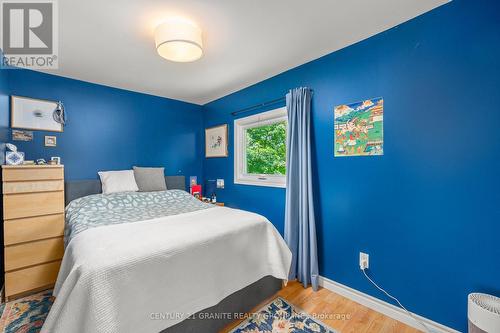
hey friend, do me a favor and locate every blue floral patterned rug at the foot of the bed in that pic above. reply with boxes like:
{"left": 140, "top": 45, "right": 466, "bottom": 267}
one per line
{"left": 230, "top": 297, "right": 338, "bottom": 333}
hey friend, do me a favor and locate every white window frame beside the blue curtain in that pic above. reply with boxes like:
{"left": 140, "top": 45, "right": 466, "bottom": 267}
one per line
{"left": 234, "top": 107, "right": 288, "bottom": 188}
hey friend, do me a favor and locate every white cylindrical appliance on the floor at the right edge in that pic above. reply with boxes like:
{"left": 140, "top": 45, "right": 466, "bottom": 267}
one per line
{"left": 468, "top": 293, "right": 500, "bottom": 333}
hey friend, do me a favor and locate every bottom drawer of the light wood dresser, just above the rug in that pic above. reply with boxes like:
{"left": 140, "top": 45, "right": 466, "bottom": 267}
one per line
{"left": 5, "top": 261, "right": 61, "bottom": 297}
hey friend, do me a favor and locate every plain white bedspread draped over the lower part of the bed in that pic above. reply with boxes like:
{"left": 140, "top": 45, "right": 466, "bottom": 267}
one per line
{"left": 42, "top": 207, "right": 291, "bottom": 333}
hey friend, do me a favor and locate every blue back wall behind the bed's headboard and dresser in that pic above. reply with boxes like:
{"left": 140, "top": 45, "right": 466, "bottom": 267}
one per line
{"left": 2, "top": 70, "right": 203, "bottom": 179}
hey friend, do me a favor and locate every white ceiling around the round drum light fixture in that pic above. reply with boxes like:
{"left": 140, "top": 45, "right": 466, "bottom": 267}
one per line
{"left": 43, "top": 0, "right": 448, "bottom": 104}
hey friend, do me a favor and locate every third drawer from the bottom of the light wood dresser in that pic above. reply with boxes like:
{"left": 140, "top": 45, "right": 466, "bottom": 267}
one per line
{"left": 3, "top": 214, "right": 64, "bottom": 245}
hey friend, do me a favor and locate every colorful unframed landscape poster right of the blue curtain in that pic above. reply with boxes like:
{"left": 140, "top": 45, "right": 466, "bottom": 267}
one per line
{"left": 334, "top": 97, "right": 384, "bottom": 157}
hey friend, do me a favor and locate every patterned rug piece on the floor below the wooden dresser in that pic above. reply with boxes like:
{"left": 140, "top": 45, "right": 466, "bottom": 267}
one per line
{"left": 0, "top": 290, "right": 54, "bottom": 333}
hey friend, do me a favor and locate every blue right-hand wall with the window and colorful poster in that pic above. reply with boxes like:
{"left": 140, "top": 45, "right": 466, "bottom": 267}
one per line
{"left": 204, "top": 0, "right": 500, "bottom": 331}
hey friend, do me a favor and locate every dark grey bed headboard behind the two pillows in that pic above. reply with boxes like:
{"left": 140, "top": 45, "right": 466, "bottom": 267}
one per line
{"left": 64, "top": 176, "right": 186, "bottom": 205}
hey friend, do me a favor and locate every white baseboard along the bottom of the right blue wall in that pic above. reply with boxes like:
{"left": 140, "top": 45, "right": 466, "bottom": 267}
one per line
{"left": 319, "top": 276, "right": 460, "bottom": 333}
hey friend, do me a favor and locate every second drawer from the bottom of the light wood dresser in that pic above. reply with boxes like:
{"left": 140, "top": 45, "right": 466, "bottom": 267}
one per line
{"left": 5, "top": 237, "right": 64, "bottom": 271}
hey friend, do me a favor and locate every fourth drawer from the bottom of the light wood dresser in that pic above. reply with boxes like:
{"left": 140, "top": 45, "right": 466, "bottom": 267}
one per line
{"left": 3, "top": 191, "right": 64, "bottom": 220}
